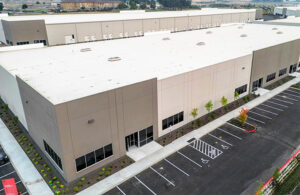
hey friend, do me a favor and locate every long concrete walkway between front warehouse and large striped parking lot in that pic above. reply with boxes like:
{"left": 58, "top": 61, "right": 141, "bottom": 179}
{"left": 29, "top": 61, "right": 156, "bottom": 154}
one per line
{"left": 78, "top": 74, "right": 300, "bottom": 195}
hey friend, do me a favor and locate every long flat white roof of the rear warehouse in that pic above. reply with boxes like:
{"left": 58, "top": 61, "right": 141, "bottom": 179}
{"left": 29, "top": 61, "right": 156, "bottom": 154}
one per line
{"left": 4, "top": 8, "right": 255, "bottom": 24}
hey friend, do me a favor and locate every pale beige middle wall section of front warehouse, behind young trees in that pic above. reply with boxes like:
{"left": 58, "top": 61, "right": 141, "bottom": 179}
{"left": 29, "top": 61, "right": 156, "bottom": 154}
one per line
{"left": 157, "top": 54, "right": 252, "bottom": 136}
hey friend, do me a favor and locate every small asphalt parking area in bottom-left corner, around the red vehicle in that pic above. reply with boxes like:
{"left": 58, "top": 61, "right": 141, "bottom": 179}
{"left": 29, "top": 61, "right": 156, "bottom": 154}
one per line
{"left": 0, "top": 146, "right": 28, "bottom": 195}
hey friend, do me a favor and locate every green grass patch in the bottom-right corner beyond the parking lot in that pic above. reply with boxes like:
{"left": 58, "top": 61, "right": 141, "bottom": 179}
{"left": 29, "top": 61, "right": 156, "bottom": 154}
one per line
{"left": 274, "top": 165, "right": 300, "bottom": 195}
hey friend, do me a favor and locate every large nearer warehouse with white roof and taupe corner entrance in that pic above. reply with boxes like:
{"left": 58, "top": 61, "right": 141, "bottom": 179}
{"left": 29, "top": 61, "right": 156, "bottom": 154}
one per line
{"left": 0, "top": 24, "right": 300, "bottom": 182}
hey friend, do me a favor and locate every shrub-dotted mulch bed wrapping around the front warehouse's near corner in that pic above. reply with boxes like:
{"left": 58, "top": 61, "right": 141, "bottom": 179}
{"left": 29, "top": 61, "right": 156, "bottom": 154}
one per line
{"left": 0, "top": 99, "right": 134, "bottom": 194}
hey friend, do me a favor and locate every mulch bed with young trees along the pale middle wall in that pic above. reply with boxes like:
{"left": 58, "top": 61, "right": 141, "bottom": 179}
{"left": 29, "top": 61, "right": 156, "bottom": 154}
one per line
{"left": 156, "top": 94, "right": 258, "bottom": 146}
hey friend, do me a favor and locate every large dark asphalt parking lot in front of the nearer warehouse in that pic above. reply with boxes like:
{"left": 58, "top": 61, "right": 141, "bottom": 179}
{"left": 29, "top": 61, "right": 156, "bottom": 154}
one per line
{"left": 106, "top": 88, "right": 300, "bottom": 195}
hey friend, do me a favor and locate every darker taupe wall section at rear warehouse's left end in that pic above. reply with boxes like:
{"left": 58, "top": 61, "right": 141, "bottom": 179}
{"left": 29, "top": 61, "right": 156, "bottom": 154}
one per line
{"left": 2, "top": 20, "right": 48, "bottom": 45}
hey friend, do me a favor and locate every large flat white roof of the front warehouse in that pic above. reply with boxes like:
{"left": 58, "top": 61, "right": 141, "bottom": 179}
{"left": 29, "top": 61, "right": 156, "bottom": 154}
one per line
{"left": 0, "top": 24, "right": 300, "bottom": 104}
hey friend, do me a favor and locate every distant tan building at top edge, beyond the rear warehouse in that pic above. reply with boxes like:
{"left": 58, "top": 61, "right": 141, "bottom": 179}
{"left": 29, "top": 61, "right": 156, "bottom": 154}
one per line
{"left": 61, "top": 0, "right": 121, "bottom": 10}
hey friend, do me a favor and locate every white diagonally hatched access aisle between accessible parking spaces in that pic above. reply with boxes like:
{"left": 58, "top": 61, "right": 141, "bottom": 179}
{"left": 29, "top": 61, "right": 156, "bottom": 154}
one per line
{"left": 189, "top": 139, "right": 223, "bottom": 159}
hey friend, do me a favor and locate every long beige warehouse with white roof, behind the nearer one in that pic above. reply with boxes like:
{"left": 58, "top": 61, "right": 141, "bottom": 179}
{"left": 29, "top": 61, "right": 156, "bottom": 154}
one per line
{"left": 0, "top": 9, "right": 256, "bottom": 46}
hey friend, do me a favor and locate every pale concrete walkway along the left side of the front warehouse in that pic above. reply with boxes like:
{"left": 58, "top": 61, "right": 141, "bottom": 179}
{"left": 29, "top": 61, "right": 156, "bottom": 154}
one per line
{"left": 0, "top": 120, "right": 53, "bottom": 195}
